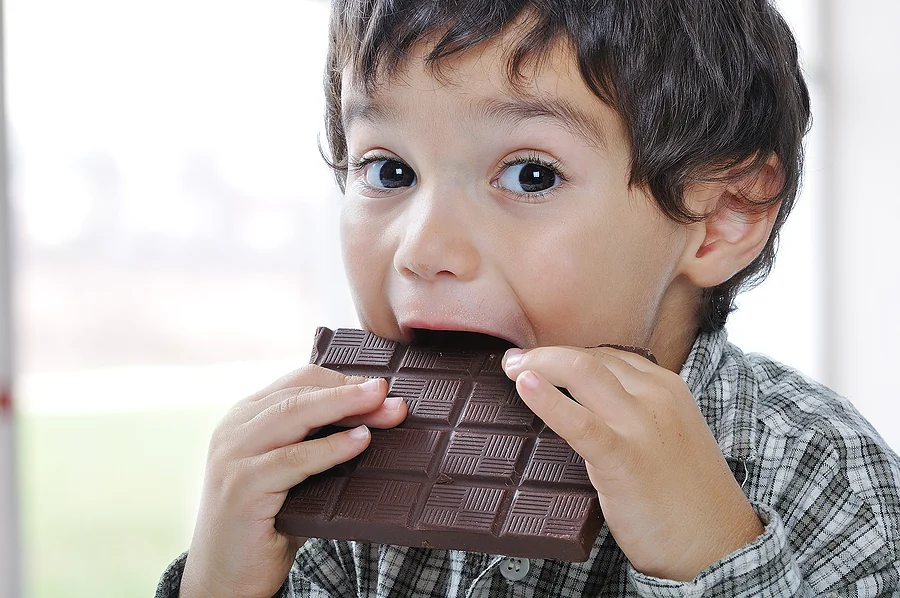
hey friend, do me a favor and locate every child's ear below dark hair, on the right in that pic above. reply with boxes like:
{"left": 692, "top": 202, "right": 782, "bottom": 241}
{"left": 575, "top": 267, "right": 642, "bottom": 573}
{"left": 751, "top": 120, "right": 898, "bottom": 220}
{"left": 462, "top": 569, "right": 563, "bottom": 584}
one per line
{"left": 680, "top": 155, "right": 782, "bottom": 288}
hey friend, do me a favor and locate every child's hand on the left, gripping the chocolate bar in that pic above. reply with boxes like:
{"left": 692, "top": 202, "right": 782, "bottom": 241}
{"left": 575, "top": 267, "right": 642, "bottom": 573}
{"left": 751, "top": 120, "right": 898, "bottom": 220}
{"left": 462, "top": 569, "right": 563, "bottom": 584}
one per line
{"left": 180, "top": 365, "right": 406, "bottom": 598}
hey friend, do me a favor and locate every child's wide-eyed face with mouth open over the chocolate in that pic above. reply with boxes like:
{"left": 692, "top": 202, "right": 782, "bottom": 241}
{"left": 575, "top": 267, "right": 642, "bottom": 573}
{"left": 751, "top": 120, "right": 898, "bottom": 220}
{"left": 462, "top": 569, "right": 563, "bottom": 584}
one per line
{"left": 341, "top": 39, "right": 696, "bottom": 348}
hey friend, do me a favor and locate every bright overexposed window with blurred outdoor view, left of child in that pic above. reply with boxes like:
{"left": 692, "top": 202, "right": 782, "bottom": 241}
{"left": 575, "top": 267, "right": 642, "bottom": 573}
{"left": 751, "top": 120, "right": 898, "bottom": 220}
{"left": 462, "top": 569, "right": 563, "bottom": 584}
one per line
{"left": 3, "top": 0, "right": 355, "bottom": 597}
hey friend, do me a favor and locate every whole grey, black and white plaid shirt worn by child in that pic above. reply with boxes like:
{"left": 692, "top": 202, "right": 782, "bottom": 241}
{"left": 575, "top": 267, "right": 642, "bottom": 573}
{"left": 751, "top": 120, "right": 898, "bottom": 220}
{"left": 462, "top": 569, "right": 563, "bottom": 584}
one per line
{"left": 156, "top": 331, "right": 900, "bottom": 598}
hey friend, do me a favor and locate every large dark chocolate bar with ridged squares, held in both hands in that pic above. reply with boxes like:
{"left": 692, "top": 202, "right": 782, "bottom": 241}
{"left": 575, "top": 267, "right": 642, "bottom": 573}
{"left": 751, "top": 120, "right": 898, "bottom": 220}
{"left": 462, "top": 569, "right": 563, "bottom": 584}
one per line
{"left": 275, "top": 328, "right": 603, "bottom": 561}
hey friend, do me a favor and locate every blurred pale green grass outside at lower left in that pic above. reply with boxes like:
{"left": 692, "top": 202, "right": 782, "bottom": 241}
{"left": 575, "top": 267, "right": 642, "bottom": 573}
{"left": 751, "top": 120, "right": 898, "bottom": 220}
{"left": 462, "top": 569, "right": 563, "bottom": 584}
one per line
{"left": 17, "top": 408, "right": 224, "bottom": 598}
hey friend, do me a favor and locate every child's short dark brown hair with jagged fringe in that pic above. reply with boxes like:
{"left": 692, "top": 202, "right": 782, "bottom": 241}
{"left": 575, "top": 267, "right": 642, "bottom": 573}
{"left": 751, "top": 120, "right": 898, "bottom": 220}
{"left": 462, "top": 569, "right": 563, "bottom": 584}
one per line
{"left": 325, "top": 0, "right": 810, "bottom": 331}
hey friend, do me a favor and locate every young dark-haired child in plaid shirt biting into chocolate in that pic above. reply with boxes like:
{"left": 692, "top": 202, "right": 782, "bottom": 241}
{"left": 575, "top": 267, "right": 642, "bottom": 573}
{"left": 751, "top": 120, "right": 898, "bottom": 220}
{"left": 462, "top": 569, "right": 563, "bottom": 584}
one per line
{"left": 157, "top": 0, "right": 900, "bottom": 598}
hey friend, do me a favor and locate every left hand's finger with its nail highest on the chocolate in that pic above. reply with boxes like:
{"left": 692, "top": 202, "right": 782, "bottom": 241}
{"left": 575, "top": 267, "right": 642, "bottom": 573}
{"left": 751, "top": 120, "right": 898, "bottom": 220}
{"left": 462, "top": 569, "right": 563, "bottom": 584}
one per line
{"left": 241, "top": 378, "right": 387, "bottom": 455}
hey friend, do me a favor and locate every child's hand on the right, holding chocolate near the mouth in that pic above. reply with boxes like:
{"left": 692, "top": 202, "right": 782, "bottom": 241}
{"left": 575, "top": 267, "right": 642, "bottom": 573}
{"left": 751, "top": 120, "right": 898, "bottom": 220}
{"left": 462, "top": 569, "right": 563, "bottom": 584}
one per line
{"left": 504, "top": 347, "right": 763, "bottom": 581}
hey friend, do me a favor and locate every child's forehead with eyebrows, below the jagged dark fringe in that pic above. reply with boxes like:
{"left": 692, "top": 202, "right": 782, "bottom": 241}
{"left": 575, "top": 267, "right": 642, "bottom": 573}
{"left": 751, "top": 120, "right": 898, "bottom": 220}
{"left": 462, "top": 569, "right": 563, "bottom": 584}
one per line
{"left": 341, "top": 37, "right": 622, "bottom": 151}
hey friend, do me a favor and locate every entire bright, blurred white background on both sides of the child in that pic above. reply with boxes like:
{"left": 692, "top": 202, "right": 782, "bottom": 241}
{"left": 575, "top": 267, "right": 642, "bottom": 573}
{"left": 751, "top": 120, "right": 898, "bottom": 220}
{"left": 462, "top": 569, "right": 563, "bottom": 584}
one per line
{"left": 0, "top": 0, "right": 900, "bottom": 598}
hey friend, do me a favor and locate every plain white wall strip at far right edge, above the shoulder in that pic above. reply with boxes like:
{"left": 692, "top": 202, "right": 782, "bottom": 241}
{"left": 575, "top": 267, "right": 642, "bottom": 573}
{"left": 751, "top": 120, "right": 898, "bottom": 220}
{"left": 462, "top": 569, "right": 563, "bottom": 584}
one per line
{"left": 823, "top": 0, "right": 900, "bottom": 449}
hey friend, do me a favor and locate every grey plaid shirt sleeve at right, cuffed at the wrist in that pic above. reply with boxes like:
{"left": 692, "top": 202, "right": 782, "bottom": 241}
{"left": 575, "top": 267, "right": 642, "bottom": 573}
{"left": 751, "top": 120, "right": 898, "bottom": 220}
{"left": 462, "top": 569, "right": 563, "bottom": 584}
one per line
{"left": 628, "top": 424, "right": 900, "bottom": 598}
